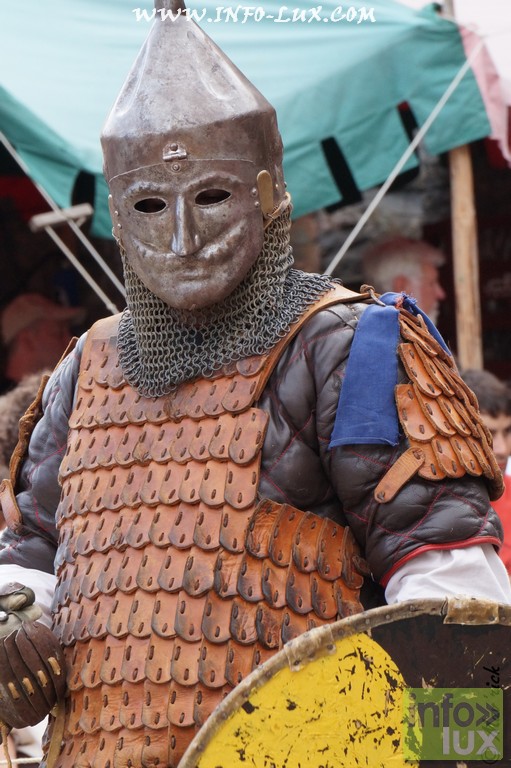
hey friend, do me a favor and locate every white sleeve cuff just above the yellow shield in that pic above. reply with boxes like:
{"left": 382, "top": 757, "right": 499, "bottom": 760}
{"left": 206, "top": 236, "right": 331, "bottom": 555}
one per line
{"left": 385, "top": 544, "right": 511, "bottom": 604}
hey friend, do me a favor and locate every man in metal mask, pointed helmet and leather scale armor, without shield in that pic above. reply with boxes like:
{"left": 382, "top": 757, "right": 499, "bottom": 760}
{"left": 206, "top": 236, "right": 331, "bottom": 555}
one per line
{"left": 0, "top": 2, "right": 511, "bottom": 768}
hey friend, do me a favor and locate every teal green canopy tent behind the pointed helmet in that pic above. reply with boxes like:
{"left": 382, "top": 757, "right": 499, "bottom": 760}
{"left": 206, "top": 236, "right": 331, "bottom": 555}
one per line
{"left": 0, "top": 0, "right": 490, "bottom": 237}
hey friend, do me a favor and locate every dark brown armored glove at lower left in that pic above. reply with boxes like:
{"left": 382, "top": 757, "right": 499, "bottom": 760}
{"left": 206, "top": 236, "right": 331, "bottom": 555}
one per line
{"left": 0, "top": 583, "right": 66, "bottom": 728}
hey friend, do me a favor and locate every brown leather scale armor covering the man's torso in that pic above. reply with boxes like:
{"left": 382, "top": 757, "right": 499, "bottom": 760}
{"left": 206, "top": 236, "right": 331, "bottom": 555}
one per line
{"left": 46, "top": 287, "right": 363, "bottom": 768}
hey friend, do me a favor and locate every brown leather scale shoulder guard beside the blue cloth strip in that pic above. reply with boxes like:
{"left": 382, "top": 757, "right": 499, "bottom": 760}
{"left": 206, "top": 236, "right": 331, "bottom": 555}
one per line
{"left": 374, "top": 309, "right": 504, "bottom": 503}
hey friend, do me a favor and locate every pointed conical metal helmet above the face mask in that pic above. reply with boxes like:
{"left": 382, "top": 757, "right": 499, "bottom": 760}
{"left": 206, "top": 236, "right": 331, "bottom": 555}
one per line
{"left": 101, "top": 0, "right": 286, "bottom": 215}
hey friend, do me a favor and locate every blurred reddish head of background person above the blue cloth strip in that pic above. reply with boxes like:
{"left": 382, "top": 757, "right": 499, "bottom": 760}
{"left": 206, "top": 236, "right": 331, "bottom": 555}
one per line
{"left": 362, "top": 237, "right": 446, "bottom": 324}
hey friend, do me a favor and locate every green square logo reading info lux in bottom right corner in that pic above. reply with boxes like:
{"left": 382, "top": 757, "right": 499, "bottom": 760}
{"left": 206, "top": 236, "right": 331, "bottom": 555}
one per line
{"left": 403, "top": 688, "right": 503, "bottom": 761}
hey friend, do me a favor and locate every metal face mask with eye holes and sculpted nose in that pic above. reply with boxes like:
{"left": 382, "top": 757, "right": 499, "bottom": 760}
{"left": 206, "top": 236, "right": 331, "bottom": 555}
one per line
{"left": 110, "top": 159, "right": 264, "bottom": 309}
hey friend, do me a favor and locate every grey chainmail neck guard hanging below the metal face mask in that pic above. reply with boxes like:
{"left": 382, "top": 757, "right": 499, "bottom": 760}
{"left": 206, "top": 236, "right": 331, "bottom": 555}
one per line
{"left": 117, "top": 211, "right": 339, "bottom": 397}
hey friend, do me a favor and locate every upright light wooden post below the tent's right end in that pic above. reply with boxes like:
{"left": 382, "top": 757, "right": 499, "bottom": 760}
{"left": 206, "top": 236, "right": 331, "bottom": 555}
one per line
{"left": 449, "top": 145, "right": 484, "bottom": 369}
